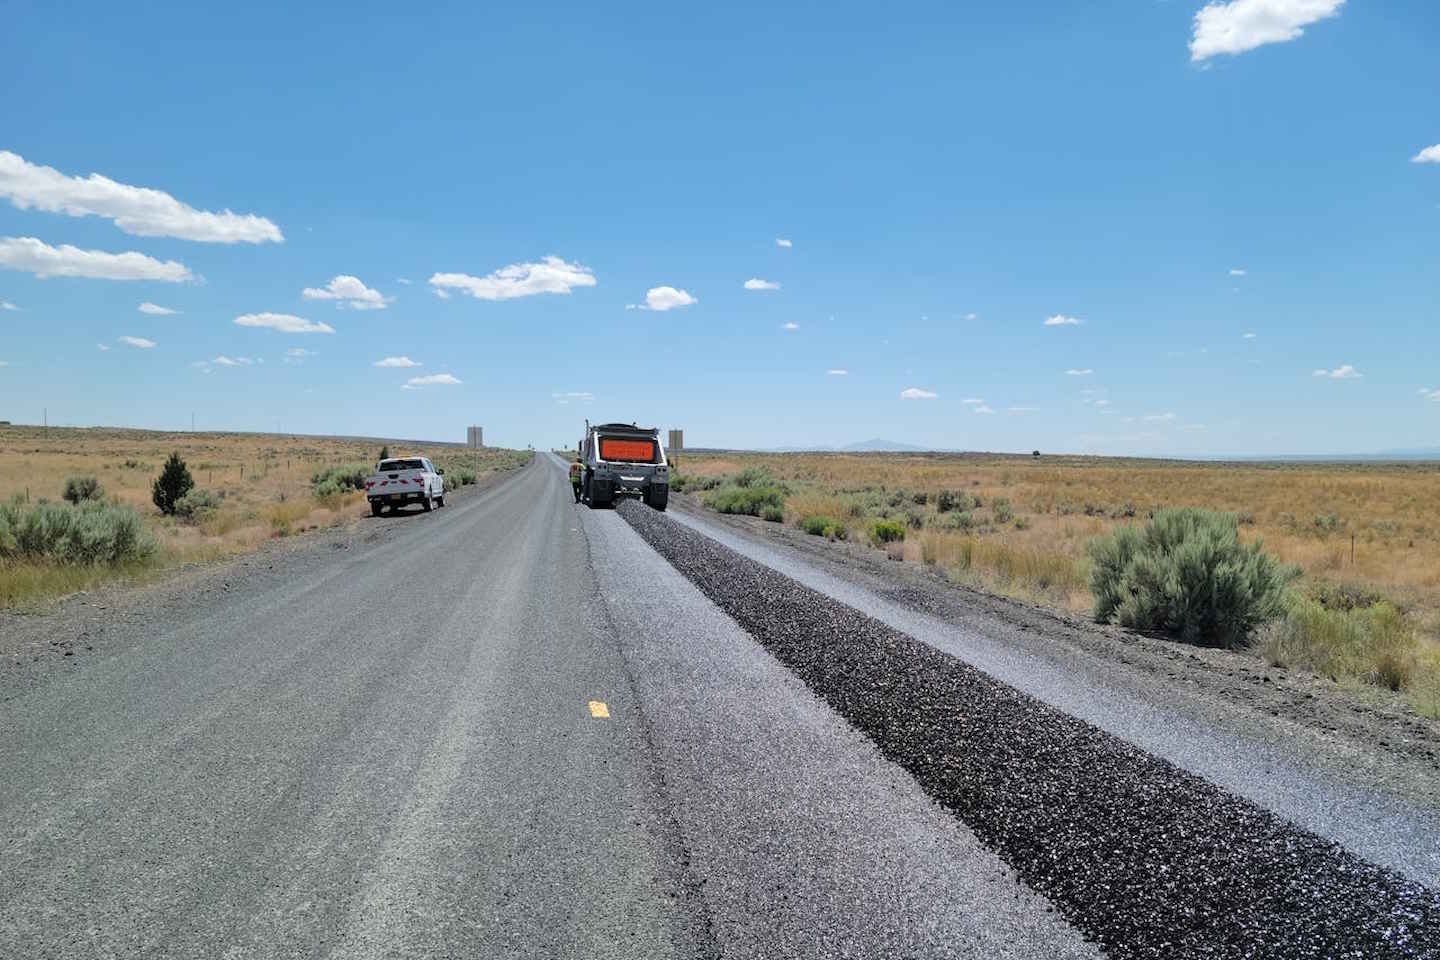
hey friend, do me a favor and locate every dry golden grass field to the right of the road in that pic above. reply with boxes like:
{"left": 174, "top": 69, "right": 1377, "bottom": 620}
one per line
{"left": 680, "top": 453, "right": 1440, "bottom": 712}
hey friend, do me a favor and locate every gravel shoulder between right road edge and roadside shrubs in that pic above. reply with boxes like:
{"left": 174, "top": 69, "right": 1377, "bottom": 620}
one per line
{"left": 671, "top": 495, "right": 1440, "bottom": 788}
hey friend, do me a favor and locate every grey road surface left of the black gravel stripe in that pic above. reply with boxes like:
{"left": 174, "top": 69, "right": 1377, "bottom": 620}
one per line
{"left": 0, "top": 458, "right": 1096, "bottom": 960}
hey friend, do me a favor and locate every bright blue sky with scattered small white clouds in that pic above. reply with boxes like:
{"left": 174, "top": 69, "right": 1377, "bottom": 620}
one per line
{"left": 0, "top": 0, "right": 1440, "bottom": 455}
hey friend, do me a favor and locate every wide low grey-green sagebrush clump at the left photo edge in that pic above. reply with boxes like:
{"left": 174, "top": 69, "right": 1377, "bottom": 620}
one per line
{"left": 0, "top": 499, "right": 156, "bottom": 564}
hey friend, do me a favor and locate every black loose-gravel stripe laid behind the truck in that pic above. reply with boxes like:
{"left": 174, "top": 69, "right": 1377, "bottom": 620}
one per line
{"left": 619, "top": 502, "right": 1440, "bottom": 960}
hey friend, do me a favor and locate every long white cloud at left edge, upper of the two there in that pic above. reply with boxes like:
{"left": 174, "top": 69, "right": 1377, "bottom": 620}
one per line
{"left": 0, "top": 150, "right": 285, "bottom": 243}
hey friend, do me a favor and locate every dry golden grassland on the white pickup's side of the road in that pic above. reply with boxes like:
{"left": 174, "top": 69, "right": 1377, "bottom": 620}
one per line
{"left": 0, "top": 426, "right": 528, "bottom": 607}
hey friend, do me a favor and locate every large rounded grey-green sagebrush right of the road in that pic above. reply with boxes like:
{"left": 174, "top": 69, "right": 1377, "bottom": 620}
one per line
{"left": 1089, "top": 507, "right": 1299, "bottom": 648}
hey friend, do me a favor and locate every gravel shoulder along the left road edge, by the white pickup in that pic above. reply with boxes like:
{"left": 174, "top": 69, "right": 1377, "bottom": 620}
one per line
{"left": 0, "top": 468, "right": 526, "bottom": 704}
